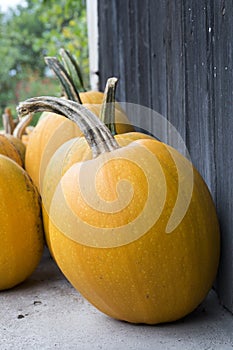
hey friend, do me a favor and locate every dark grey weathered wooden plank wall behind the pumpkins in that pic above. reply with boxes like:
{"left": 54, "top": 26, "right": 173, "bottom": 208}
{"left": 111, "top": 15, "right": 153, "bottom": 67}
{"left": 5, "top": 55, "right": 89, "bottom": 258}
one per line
{"left": 98, "top": 0, "right": 233, "bottom": 311}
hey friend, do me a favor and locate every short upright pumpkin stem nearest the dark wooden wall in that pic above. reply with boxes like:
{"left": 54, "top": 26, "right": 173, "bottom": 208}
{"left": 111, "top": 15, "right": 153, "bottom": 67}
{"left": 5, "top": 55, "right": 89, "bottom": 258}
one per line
{"left": 100, "top": 77, "right": 118, "bottom": 135}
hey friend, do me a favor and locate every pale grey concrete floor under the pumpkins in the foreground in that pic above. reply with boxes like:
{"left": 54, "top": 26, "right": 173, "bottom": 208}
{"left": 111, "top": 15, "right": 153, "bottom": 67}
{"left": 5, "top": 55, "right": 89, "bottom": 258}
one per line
{"left": 0, "top": 252, "right": 233, "bottom": 350}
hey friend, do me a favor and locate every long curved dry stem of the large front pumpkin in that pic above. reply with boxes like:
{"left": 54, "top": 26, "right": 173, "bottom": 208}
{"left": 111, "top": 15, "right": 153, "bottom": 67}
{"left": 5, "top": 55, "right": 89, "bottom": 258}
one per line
{"left": 17, "top": 96, "right": 120, "bottom": 157}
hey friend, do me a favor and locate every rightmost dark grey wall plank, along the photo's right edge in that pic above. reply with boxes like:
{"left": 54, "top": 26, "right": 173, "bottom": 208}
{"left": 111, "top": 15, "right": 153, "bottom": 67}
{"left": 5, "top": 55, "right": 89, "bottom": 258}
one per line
{"left": 212, "top": 0, "right": 233, "bottom": 311}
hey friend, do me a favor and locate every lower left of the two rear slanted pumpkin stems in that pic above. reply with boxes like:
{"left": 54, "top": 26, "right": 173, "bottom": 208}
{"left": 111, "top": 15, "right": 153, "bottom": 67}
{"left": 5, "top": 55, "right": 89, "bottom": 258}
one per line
{"left": 44, "top": 57, "right": 82, "bottom": 104}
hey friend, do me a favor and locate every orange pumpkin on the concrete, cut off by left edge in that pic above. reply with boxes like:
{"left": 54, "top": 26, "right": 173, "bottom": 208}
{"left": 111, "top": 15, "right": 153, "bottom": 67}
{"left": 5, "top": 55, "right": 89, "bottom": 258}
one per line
{"left": 0, "top": 156, "right": 44, "bottom": 290}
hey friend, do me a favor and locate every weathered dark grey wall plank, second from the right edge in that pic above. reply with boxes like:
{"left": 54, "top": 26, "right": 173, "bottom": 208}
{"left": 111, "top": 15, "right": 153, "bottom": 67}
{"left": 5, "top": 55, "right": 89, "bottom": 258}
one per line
{"left": 184, "top": 0, "right": 215, "bottom": 193}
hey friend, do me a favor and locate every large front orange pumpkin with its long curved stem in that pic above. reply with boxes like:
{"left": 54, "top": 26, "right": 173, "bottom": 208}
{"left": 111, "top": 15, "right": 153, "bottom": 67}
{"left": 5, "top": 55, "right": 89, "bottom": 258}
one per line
{"left": 18, "top": 97, "right": 220, "bottom": 324}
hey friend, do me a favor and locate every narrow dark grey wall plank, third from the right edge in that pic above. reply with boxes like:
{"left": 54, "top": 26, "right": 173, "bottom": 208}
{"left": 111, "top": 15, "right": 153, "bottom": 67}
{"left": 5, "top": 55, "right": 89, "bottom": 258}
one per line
{"left": 166, "top": 1, "right": 188, "bottom": 151}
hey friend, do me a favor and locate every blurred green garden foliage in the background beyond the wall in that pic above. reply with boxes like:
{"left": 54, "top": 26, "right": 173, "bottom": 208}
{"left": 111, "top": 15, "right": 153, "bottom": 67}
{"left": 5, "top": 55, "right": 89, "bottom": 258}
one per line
{"left": 0, "top": 0, "right": 89, "bottom": 126}
